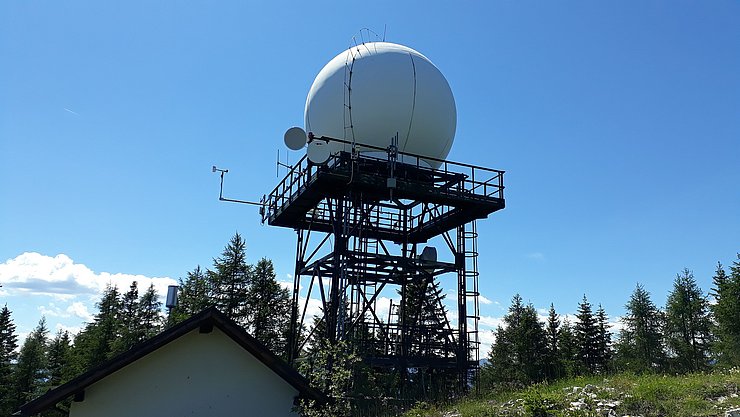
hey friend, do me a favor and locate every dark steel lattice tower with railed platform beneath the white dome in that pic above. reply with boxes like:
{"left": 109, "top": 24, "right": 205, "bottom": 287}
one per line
{"left": 262, "top": 138, "right": 505, "bottom": 398}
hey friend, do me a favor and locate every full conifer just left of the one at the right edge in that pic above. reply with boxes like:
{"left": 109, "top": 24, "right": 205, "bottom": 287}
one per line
{"left": 665, "top": 269, "right": 711, "bottom": 372}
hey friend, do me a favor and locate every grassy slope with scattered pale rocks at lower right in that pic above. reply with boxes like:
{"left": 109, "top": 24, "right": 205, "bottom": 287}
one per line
{"left": 405, "top": 369, "right": 740, "bottom": 417}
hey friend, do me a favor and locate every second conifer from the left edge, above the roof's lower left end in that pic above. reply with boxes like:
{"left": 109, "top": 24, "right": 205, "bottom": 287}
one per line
{"left": 11, "top": 317, "right": 49, "bottom": 408}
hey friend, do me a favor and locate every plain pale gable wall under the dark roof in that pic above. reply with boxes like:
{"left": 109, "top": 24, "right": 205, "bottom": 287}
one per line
{"left": 70, "top": 327, "right": 298, "bottom": 417}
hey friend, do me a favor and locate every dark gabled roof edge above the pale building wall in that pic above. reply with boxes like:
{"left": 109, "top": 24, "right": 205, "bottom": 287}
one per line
{"left": 15, "top": 307, "right": 328, "bottom": 416}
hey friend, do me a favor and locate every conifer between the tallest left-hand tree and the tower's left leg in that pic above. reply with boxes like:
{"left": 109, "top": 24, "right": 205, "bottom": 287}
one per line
{"left": 246, "top": 258, "right": 291, "bottom": 357}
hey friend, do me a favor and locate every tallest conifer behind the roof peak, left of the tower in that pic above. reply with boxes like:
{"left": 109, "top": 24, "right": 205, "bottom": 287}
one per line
{"left": 208, "top": 233, "right": 251, "bottom": 326}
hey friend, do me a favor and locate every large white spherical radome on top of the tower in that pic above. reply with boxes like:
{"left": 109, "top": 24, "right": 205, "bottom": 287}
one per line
{"left": 305, "top": 42, "right": 457, "bottom": 168}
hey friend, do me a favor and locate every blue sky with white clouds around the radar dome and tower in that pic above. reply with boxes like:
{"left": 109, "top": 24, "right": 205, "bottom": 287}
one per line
{"left": 0, "top": 1, "right": 740, "bottom": 353}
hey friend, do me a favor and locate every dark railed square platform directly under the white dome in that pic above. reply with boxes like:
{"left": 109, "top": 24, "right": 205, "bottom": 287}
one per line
{"left": 262, "top": 141, "right": 505, "bottom": 243}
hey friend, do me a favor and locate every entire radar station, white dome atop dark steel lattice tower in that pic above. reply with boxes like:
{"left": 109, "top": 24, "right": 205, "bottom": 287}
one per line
{"left": 214, "top": 42, "right": 505, "bottom": 397}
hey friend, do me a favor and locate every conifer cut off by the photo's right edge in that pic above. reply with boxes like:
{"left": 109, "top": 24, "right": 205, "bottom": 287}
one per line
{"left": 712, "top": 254, "right": 740, "bottom": 366}
